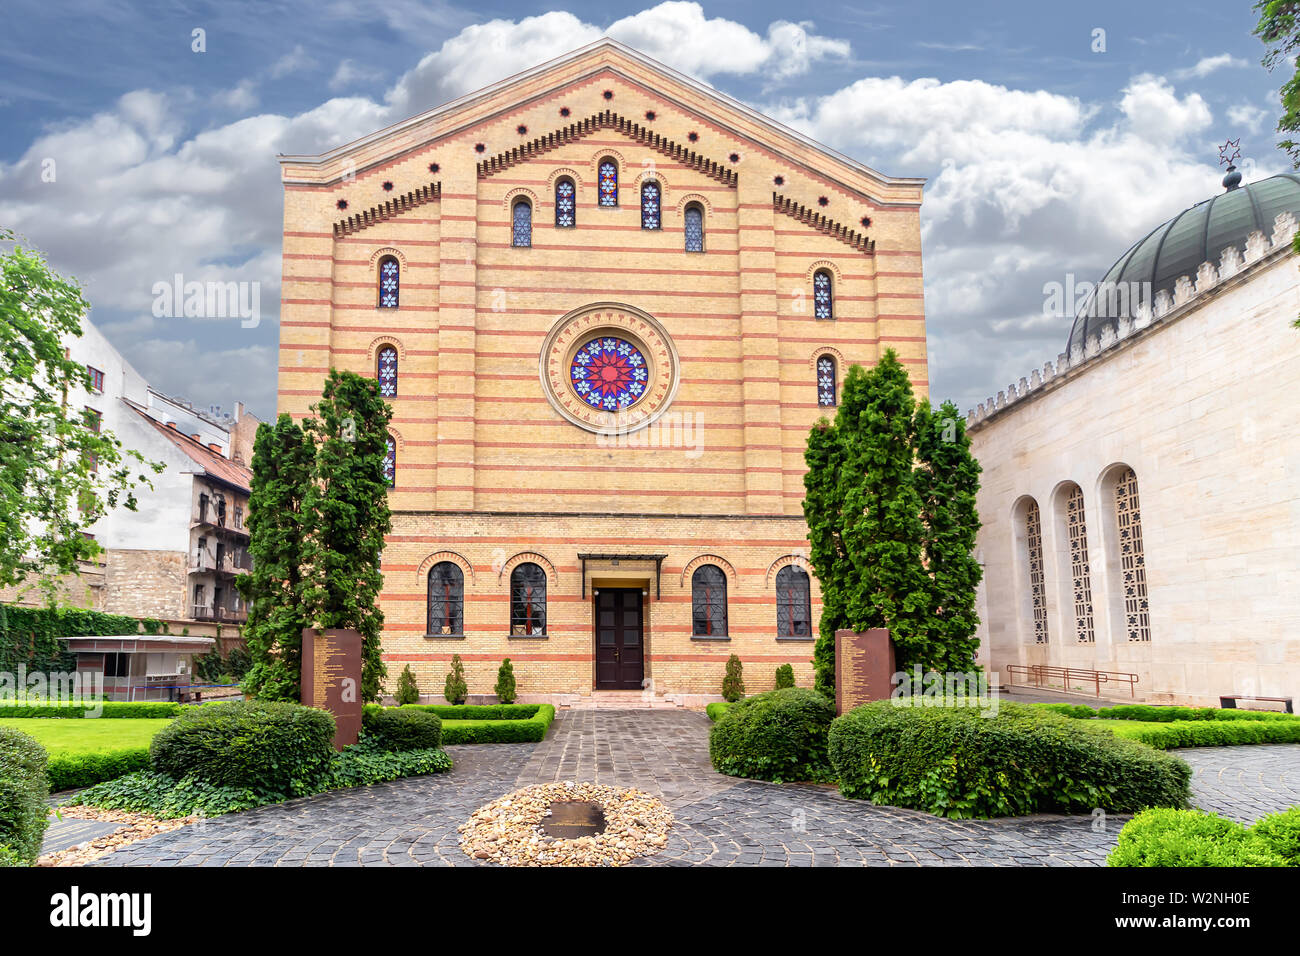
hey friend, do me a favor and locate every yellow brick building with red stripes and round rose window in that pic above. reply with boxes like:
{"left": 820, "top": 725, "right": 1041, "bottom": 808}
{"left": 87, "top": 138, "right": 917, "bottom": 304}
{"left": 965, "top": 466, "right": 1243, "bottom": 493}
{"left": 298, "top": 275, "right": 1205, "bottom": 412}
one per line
{"left": 280, "top": 40, "right": 927, "bottom": 700}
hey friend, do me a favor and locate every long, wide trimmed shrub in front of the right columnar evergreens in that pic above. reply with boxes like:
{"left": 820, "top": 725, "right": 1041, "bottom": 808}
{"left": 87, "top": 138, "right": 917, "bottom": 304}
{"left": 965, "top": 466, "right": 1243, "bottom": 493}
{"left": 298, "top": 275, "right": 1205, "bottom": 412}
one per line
{"left": 829, "top": 701, "right": 1191, "bottom": 818}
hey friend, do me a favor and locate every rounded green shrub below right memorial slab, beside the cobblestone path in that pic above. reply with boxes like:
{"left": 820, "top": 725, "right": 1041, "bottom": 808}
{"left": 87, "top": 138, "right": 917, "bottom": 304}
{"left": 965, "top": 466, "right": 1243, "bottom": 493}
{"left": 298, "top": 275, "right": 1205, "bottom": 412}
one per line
{"left": 709, "top": 687, "right": 835, "bottom": 783}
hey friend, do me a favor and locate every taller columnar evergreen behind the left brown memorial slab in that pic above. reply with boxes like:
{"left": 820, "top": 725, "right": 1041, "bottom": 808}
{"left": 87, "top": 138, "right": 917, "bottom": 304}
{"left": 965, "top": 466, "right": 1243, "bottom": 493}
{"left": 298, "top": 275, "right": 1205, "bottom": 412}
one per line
{"left": 302, "top": 368, "right": 393, "bottom": 701}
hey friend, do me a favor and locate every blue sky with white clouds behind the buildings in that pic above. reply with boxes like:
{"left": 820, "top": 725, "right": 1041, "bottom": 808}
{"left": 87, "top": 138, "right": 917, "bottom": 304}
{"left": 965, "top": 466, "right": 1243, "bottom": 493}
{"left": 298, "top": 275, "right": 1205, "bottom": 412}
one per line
{"left": 0, "top": 0, "right": 1287, "bottom": 416}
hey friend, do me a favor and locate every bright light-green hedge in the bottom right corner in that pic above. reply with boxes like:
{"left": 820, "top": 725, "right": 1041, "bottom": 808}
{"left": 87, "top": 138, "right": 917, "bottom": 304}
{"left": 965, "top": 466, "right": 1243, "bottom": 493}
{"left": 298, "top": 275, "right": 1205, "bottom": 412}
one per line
{"left": 1106, "top": 806, "right": 1300, "bottom": 866}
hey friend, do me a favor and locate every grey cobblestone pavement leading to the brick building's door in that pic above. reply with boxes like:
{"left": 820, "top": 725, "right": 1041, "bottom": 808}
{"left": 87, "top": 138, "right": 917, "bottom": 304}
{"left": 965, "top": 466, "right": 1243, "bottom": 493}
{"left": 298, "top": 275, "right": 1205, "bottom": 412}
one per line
{"left": 86, "top": 710, "right": 1300, "bottom": 866}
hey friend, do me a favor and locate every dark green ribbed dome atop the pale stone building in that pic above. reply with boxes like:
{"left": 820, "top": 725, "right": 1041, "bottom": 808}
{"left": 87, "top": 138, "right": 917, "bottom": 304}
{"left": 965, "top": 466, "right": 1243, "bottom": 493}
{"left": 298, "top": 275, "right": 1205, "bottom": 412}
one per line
{"left": 1066, "top": 173, "right": 1300, "bottom": 350}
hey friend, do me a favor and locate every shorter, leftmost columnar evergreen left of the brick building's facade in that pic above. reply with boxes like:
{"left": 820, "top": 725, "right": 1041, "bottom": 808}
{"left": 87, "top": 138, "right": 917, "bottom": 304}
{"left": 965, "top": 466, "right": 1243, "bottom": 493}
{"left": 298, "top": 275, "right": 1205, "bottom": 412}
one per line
{"left": 235, "top": 414, "right": 315, "bottom": 701}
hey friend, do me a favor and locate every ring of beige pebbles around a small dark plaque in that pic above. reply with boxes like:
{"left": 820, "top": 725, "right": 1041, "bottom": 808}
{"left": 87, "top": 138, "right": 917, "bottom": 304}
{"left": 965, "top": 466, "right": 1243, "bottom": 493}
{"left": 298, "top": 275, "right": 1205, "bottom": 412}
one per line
{"left": 459, "top": 782, "right": 672, "bottom": 866}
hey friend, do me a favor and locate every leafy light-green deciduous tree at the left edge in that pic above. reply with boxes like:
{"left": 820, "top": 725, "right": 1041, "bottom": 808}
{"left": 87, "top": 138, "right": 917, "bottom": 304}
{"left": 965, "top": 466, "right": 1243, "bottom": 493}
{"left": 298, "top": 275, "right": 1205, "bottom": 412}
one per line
{"left": 0, "top": 230, "right": 164, "bottom": 605}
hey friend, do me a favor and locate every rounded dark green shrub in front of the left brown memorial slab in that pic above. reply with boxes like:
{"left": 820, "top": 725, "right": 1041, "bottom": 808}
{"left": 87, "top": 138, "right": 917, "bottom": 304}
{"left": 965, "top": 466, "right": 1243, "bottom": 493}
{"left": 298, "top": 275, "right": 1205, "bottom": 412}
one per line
{"left": 150, "top": 701, "right": 334, "bottom": 796}
